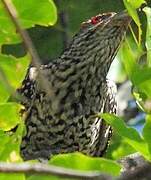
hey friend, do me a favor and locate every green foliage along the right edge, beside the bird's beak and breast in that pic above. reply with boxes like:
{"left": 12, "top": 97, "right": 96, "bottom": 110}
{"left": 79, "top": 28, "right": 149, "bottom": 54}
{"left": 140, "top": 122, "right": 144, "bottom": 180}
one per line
{"left": 104, "top": 1, "right": 151, "bottom": 160}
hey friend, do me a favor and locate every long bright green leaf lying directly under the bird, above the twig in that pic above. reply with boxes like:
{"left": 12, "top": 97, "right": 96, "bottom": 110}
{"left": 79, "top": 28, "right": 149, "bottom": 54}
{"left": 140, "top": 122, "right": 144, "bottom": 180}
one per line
{"left": 50, "top": 153, "right": 121, "bottom": 176}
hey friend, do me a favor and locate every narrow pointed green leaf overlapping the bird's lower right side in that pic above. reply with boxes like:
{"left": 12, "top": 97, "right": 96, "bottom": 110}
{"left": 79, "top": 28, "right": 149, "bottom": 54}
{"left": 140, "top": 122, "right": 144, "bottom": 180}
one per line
{"left": 99, "top": 113, "right": 151, "bottom": 159}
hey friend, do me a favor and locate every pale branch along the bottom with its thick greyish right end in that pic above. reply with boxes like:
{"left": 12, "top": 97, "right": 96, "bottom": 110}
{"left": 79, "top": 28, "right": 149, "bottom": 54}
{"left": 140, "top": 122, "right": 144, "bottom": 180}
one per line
{"left": 0, "top": 153, "right": 151, "bottom": 180}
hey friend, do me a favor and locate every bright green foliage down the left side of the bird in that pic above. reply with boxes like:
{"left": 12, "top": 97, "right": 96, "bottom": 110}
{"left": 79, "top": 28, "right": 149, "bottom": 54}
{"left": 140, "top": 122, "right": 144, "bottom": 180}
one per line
{"left": 0, "top": 0, "right": 57, "bottom": 180}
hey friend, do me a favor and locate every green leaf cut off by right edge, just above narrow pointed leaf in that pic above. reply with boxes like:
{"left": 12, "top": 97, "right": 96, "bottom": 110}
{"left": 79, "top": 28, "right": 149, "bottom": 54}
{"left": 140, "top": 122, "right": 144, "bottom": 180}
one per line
{"left": 143, "top": 115, "right": 151, "bottom": 154}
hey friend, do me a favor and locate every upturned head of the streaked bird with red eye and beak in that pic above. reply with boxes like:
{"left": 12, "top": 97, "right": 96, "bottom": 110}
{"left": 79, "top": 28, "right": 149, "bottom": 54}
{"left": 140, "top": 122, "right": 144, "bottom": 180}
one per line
{"left": 80, "top": 12, "right": 131, "bottom": 43}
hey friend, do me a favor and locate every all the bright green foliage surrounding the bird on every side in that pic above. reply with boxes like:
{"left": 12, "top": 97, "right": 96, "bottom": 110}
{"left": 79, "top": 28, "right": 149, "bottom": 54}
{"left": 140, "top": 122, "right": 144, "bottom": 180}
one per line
{"left": 0, "top": 0, "right": 151, "bottom": 180}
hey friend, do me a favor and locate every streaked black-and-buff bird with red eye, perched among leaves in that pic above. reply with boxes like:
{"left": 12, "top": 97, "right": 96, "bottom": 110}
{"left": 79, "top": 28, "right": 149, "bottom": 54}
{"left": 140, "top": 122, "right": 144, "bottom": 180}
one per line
{"left": 18, "top": 11, "right": 131, "bottom": 160}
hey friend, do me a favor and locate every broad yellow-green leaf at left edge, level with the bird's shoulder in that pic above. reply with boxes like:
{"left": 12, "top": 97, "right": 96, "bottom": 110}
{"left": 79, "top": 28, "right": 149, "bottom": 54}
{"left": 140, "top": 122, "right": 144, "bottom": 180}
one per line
{"left": 0, "top": 54, "right": 30, "bottom": 103}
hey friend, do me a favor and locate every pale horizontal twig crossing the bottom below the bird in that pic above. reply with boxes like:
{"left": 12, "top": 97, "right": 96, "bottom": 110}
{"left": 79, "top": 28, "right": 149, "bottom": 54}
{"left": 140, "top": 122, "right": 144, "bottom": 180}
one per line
{"left": 0, "top": 163, "right": 111, "bottom": 180}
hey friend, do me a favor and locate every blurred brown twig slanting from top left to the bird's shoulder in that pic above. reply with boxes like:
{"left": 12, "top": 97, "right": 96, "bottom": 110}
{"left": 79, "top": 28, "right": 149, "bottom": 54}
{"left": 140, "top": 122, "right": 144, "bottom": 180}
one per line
{"left": 2, "top": 0, "right": 51, "bottom": 96}
